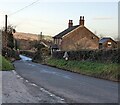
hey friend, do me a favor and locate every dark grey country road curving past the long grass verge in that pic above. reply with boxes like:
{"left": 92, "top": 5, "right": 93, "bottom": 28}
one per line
{"left": 14, "top": 56, "right": 118, "bottom": 103}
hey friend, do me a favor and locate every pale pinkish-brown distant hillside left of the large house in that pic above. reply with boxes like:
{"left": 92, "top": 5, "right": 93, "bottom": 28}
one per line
{"left": 14, "top": 32, "right": 52, "bottom": 41}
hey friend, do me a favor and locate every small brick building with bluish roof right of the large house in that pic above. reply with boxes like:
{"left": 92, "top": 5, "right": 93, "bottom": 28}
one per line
{"left": 99, "top": 37, "right": 117, "bottom": 49}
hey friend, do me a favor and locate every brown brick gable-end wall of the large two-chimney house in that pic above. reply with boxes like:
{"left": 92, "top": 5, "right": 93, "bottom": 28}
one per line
{"left": 61, "top": 26, "right": 99, "bottom": 51}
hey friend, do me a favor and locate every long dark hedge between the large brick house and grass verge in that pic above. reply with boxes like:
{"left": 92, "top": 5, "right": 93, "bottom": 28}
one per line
{"left": 52, "top": 49, "right": 120, "bottom": 63}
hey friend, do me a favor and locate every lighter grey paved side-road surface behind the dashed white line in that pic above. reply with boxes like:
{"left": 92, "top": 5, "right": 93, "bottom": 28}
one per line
{"left": 0, "top": 71, "right": 64, "bottom": 105}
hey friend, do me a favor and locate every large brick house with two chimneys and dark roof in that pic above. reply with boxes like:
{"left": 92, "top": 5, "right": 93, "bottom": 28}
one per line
{"left": 53, "top": 16, "right": 99, "bottom": 51}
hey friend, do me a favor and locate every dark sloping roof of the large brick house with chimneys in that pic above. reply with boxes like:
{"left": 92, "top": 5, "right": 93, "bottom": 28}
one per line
{"left": 53, "top": 25, "right": 80, "bottom": 38}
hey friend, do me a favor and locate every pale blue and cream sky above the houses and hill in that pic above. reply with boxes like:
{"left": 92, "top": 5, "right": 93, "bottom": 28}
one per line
{"left": 0, "top": 0, "right": 118, "bottom": 39}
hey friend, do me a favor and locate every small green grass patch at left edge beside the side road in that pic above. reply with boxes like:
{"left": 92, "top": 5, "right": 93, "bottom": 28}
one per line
{"left": 0, "top": 55, "right": 14, "bottom": 71}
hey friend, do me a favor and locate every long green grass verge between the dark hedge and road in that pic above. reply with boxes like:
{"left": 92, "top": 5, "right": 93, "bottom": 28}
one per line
{"left": 46, "top": 58, "right": 120, "bottom": 81}
